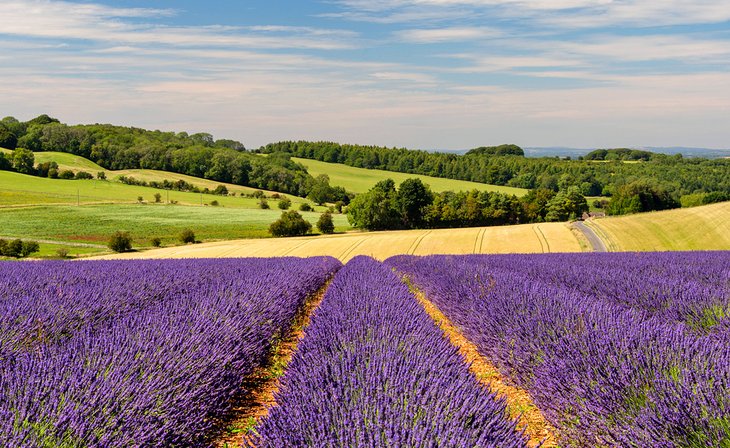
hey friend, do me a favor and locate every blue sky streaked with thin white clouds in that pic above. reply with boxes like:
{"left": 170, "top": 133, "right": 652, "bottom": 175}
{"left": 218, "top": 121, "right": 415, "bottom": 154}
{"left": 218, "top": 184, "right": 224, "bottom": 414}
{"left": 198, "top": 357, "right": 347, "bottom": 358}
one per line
{"left": 0, "top": 0, "right": 730, "bottom": 150}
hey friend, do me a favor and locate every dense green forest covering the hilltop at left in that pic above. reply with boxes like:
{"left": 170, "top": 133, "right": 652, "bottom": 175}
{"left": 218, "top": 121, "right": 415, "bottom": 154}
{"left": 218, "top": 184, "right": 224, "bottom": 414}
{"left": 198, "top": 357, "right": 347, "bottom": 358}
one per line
{"left": 0, "top": 115, "right": 315, "bottom": 196}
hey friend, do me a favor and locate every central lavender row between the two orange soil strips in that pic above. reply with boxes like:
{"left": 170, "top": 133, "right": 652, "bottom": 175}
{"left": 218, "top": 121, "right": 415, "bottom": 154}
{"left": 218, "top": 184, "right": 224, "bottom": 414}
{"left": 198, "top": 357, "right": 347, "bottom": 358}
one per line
{"left": 245, "top": 257, "right": 526, "bottom": 448}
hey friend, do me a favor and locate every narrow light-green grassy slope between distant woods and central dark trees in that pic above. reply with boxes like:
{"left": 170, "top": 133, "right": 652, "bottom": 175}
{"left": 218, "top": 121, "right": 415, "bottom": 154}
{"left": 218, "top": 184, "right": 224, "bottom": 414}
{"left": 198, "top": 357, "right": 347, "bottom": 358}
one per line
{"left": 292, "top": 157, "right": 527, "bottom": 196}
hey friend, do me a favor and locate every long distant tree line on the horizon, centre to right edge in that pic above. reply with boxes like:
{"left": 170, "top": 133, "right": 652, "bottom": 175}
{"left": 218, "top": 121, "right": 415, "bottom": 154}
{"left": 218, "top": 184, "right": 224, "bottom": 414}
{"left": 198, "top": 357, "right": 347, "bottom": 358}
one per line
{"left": 259, "top": 141, "right": 730, "bottom": 202}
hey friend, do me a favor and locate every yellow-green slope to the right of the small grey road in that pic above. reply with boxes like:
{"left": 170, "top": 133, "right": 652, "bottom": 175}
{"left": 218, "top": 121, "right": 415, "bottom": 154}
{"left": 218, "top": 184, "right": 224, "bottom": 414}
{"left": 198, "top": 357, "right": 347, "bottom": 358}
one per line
{"left": 591, "top": 202, "right": 730, "bottom": 251}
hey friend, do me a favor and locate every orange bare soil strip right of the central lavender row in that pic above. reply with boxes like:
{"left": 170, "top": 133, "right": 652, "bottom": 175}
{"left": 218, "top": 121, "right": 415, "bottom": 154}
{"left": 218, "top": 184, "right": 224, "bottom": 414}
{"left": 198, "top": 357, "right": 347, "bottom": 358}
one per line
{"left": 411, "top": 286, "right": 558, "bottom": 448}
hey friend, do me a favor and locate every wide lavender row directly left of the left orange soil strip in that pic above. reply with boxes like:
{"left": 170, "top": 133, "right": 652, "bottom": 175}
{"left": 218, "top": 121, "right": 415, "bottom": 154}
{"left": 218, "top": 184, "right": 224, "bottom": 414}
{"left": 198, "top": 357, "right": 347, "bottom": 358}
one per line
{"left": 0, "top": 258, "right": 341, "bottom": 447}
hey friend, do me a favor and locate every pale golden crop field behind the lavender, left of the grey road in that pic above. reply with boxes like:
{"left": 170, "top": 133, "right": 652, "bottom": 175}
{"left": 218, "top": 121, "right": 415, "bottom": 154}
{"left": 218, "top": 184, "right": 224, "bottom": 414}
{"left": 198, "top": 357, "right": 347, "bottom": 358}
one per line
{"left": 103, "top": 223, "right": 581, "bottom": 262}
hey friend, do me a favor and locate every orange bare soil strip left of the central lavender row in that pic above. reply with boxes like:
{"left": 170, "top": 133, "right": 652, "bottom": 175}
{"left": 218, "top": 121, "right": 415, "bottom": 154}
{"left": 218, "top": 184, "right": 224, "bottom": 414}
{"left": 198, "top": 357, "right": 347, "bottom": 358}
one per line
{"left": 210, "top": 279, "right": 332, "bottom": 448}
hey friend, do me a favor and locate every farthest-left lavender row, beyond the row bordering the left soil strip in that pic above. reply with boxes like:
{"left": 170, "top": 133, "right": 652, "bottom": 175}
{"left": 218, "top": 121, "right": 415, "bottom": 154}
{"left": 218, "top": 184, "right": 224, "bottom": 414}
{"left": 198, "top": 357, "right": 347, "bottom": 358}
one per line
{"left": 0, "top": 261, "right": 236, "bottom": 356}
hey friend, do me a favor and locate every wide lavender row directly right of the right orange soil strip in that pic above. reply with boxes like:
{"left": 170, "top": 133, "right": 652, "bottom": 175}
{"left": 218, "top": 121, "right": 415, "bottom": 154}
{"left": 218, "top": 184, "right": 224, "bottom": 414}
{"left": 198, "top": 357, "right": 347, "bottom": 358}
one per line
{"left": 386, "top": 254, "right": 730, "bottom": 447}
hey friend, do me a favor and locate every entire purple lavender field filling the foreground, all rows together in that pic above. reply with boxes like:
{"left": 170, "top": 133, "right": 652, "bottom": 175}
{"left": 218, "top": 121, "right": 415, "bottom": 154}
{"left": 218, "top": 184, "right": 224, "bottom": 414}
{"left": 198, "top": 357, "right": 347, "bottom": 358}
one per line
{"left": 0, "top": 252, "right": 730, "bottom": 448}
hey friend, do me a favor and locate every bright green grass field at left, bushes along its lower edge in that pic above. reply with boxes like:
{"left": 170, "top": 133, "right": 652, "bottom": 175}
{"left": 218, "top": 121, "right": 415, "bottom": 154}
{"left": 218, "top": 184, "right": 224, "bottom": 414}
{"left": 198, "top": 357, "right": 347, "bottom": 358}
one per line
{"left": 0, "top": 204, "right": 350, "bottom": 253}
